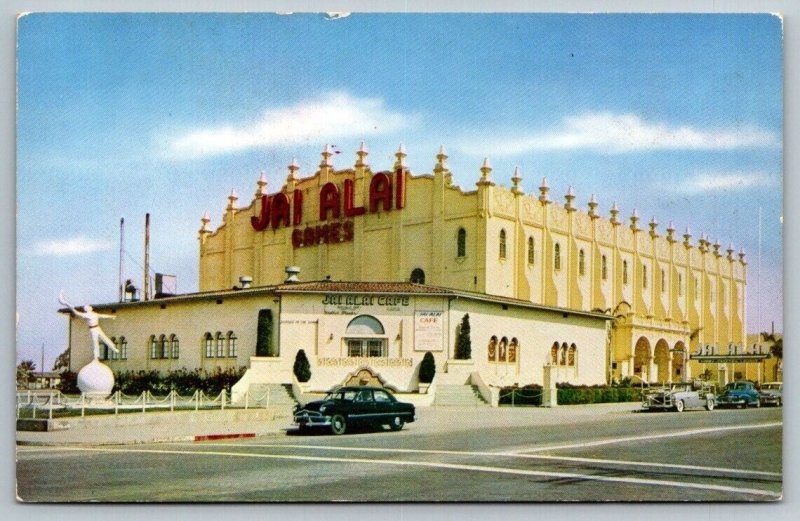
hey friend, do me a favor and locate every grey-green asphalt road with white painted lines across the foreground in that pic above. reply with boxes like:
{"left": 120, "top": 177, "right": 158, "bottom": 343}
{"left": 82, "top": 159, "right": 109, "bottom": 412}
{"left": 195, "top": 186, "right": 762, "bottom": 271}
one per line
{"left": 17, "top": 408, "right": 782, "bottom": 502}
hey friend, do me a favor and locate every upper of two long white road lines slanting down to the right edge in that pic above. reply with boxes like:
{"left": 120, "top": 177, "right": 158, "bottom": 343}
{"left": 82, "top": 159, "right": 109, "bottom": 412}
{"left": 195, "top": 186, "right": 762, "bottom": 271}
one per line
{"left": 200, "top": 443, "right": 783, "bottom": 477}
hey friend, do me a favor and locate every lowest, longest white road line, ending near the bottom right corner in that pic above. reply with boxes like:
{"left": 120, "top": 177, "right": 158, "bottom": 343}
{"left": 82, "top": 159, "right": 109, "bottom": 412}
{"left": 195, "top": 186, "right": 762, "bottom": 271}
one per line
{"left": 25, "top": 447, "right": 783, "bottom": 499}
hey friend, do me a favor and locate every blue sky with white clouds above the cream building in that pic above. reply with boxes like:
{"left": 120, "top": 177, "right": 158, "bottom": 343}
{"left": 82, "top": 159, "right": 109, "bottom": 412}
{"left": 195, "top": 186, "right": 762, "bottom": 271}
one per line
{"left": 17, "top": 13, "right": 783, "bottom": 370}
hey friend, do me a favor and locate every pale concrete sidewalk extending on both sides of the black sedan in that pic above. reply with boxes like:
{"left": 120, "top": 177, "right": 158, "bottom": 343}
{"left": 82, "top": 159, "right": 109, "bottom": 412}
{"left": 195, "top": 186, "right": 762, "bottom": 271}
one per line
{"left": 17, "top": 402, "right": 641, "bottom": 445}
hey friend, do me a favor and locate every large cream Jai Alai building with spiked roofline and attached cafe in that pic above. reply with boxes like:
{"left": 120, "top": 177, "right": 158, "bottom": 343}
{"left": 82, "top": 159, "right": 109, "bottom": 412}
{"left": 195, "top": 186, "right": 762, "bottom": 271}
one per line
{"left": 71, "top": 145, "right": 753, "bottom": 400}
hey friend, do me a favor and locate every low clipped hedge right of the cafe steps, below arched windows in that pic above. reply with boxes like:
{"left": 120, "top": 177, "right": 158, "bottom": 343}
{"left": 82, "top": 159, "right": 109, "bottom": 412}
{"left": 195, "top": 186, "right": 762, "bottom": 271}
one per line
{"left": 500, "top": 383, "right": 642, "bottom": 406}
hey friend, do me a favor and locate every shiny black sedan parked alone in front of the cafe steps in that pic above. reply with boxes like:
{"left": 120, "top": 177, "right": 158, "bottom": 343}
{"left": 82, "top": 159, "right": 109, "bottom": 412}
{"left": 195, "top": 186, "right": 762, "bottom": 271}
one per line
{"left": 294, "top": 386, "right": 416, "bottom": 434}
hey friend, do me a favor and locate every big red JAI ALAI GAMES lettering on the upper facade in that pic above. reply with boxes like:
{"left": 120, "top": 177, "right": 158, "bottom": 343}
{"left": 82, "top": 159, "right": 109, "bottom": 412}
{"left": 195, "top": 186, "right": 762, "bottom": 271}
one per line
{"left": 250, "top": 169, "right": 405, "bottom": 248}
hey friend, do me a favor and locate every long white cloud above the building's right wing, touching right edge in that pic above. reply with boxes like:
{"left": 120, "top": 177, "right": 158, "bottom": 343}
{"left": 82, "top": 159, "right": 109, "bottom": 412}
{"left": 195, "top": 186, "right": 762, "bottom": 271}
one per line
{"left": 460, "top": 112, "right": 780, "bottom": 156}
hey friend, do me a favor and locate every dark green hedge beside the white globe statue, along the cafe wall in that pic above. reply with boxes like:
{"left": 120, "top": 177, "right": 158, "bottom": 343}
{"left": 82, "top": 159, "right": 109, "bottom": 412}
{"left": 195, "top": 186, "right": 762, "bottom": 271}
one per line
{"left": 59, "top": 367, "right": 247, "bottom": 396}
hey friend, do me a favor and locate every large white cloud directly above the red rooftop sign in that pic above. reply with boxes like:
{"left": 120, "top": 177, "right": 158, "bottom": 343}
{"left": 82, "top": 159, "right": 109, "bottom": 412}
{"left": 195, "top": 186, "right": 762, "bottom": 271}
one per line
{"left": 166, "top": 92, "right": 416, "bottom": 159}
